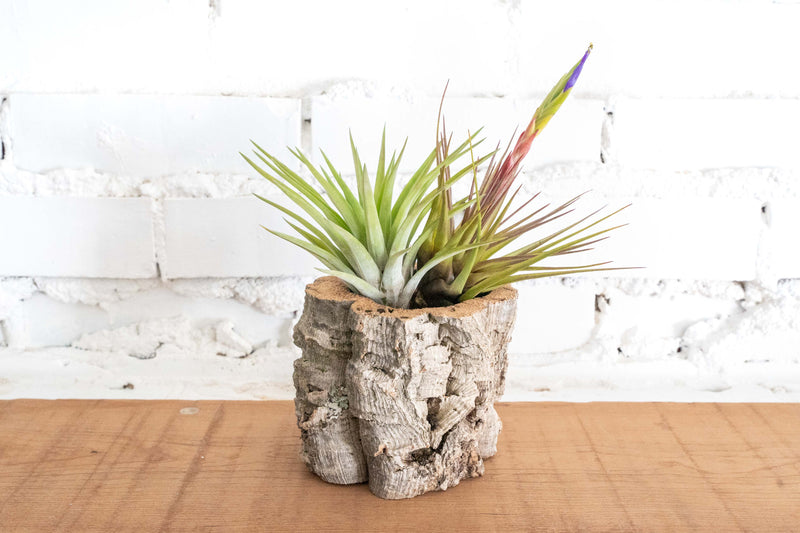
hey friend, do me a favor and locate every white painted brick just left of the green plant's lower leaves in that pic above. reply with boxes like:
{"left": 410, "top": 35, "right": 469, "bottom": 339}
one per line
{"left": 162, "top": 197, "right": 322, "bottom": 278}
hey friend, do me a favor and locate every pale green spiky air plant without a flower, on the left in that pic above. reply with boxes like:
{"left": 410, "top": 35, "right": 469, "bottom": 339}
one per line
{"left": 241, "top": 131, "right": 488, "bottom": 307}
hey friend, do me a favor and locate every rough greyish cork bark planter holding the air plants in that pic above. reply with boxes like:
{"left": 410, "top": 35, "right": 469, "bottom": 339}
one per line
{"left": 294, "top": 277, "right": 517, "bottom": 499}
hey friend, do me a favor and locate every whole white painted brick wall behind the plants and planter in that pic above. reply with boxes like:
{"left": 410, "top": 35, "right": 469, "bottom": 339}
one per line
{"left": 0, "top": 0, "right": 800, "bottom": 400}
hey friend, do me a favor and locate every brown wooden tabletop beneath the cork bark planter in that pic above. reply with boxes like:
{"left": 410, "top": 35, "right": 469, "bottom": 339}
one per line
{"left": 0, "top": 400, "right": 800, "bottom": 533}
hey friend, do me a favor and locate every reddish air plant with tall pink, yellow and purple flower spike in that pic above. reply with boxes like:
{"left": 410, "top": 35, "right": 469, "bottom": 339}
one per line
{"left": 415, "top": 45, "right": 627, "bottom": 306}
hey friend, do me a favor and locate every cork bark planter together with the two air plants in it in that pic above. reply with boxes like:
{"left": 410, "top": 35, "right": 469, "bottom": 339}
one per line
{"left": 242, "top": 46, "right": 627, "bottom": 499}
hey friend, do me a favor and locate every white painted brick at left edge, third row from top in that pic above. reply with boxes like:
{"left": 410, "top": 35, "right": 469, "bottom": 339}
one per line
{"left": 0, "top": 196, "right": 156, "bottom": 278}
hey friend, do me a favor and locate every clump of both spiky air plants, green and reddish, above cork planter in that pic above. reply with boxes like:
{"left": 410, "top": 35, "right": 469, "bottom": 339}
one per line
{"left": 242, "top": 46, "right": 627, "bottom": 308}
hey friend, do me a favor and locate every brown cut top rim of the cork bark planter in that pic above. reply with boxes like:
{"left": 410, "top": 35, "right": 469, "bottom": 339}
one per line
{"left": 306, "top": 276, "right": 517, "bottom": 320}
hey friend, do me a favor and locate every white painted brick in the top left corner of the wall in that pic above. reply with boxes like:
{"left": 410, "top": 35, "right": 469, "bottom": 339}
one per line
{"left": 0, "top": 0, "right": 209, "bottom": 93}
